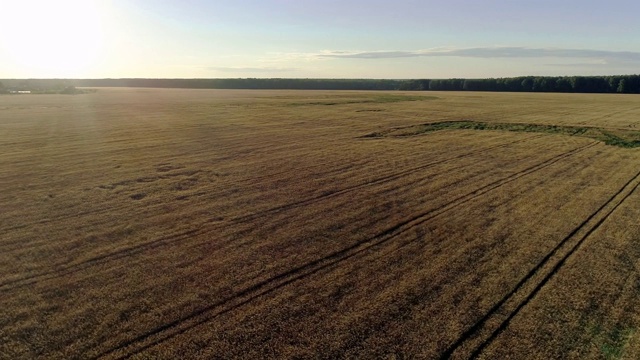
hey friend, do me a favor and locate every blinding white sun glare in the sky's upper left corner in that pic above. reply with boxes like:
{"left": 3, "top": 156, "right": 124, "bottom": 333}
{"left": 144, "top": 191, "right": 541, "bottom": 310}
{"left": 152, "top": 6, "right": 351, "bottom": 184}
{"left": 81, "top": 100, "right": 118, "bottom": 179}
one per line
{"left": 0, "top": 0, "right": 107, "bottom": 77}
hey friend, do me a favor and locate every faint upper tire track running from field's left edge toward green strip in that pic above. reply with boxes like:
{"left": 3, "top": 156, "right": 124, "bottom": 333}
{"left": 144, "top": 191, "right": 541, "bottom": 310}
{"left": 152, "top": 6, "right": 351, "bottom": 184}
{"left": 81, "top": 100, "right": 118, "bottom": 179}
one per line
{"left": 0, "top": 135, "right": 543, "bottom": 290}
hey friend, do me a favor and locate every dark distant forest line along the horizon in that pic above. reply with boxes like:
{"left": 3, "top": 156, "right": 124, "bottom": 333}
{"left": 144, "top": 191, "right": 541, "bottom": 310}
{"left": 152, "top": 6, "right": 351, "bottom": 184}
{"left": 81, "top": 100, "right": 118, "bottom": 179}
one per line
{"left": 0, "top": 75, "right": 640, "bottom": 94}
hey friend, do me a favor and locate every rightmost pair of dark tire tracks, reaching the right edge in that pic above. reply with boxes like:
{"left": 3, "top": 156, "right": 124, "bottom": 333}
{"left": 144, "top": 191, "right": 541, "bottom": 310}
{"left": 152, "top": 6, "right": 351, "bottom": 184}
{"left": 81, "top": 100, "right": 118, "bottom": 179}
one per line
{"left": 440, "top": 167, "right": 640, "bottom": 359}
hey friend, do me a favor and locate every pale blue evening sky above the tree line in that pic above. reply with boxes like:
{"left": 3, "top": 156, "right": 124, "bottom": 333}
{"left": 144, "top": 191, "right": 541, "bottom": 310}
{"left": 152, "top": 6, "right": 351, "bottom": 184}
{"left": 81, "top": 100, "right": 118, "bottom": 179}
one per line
{"left": 0, "top": 0, "right": 640, "bottom": 79}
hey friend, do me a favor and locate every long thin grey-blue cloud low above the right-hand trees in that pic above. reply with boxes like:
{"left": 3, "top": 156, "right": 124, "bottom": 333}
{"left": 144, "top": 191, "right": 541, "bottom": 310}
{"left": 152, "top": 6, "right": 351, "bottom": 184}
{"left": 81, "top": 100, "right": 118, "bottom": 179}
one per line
{"left": 316, "top": 46, "right": 640, "bottom": 63}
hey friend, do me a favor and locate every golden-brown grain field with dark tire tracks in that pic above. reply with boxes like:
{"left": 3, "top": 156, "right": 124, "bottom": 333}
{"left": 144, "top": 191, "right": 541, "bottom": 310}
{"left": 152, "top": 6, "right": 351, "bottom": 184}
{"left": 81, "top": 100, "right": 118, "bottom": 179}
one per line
{"left": 0, "top": 89, "right": 640, "bottom": 359}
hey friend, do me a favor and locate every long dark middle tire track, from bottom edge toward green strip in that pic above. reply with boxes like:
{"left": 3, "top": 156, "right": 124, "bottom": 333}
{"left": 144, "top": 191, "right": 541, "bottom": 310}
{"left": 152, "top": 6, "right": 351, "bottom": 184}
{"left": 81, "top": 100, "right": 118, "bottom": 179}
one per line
{"left": 93, "top": 142, "right": 599, "bottom": 359}
